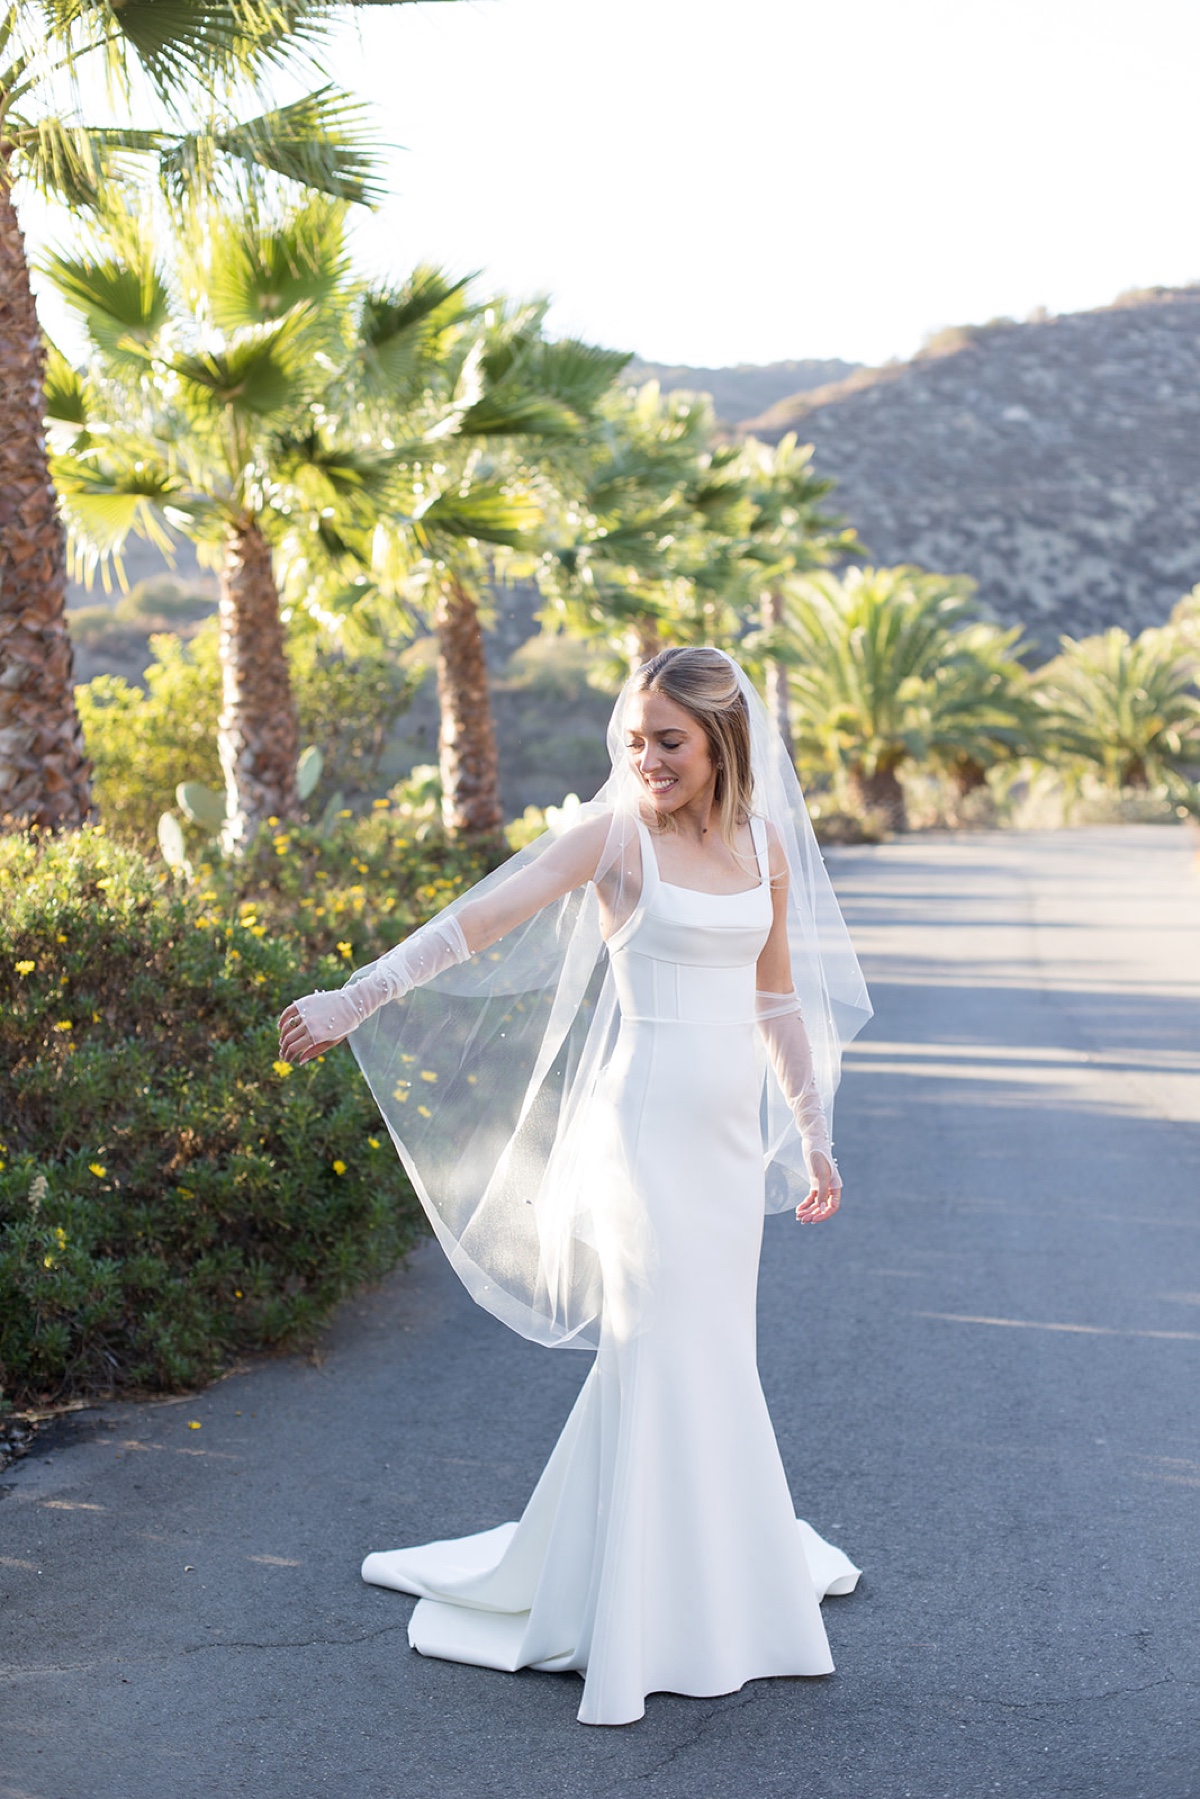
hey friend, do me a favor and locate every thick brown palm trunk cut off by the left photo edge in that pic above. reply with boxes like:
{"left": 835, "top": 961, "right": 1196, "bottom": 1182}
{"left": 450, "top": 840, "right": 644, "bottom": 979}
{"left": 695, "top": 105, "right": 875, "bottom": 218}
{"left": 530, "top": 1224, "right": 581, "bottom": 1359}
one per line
{"left": 0, "top": 167, "right": 92, "bottom": 828}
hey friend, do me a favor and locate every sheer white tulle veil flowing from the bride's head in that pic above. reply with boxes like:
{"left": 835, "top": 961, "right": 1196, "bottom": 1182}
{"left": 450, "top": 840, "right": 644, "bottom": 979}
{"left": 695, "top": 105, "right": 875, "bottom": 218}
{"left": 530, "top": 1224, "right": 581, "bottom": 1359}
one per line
{"left": 351, "top": 658, "right": 871, "bottom": 1347}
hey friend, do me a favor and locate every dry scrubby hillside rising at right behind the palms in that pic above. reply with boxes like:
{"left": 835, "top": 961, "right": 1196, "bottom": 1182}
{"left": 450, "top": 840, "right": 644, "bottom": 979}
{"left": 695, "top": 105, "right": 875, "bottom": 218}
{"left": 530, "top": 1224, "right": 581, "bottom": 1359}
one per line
{"left": 726, "top": 286, "right": 1200, "bottom": 649}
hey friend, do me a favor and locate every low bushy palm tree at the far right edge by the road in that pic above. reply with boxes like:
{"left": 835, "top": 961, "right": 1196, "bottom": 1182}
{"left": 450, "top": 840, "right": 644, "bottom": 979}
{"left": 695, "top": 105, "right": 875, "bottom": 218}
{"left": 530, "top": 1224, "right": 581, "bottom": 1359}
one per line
{"left": 1033, "top": 633, "right": 1200, "bottom": 811}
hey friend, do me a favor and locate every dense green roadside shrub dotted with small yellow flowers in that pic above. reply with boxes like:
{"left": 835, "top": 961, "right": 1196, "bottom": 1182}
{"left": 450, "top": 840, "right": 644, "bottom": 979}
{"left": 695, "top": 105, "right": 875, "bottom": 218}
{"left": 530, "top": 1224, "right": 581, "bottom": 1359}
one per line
{"left": 0, "top": 823, "right": 477, "bottom": 1403}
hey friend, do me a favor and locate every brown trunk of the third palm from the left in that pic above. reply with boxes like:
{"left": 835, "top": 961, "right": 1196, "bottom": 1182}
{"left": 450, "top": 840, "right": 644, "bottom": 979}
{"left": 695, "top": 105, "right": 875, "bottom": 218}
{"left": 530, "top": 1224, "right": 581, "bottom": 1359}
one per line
{"left": 434, "top": 574, "right": 504, "bottom": 847}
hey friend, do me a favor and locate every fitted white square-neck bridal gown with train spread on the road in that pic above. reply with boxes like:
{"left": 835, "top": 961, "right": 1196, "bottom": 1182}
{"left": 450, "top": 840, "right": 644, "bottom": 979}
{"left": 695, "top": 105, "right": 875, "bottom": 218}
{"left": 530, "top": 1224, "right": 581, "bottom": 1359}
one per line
{"left": 363, "top": 820, "right": 858, "bottom": 1723}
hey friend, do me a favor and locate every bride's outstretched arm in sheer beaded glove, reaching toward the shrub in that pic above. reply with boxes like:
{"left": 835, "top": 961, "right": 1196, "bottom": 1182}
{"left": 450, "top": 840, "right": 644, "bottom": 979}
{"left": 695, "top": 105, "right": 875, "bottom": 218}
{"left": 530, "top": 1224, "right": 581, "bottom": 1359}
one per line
{"left": 279, "top": 813, "right": 610, "bottom": 1063}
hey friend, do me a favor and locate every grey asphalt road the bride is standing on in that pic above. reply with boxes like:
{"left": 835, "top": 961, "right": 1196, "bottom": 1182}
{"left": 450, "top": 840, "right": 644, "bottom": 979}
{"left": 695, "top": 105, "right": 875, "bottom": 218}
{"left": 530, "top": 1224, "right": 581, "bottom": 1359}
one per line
{"left": 0, "top": 828, "right": 1200, "bottom": 1799}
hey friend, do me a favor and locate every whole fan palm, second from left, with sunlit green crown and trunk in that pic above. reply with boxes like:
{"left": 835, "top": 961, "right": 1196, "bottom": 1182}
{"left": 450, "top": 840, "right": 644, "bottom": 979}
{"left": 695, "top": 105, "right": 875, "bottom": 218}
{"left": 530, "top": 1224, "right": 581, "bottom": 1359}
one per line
{"left": 47, "top": 198, "right": 389, "bottom": 851}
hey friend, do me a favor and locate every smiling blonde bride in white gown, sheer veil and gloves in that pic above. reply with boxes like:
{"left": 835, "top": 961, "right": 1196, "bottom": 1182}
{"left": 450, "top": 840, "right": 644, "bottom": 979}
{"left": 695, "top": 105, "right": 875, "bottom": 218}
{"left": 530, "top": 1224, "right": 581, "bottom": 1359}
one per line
{"left": 281, "top": 649, "right": 871, "bottom": 1723}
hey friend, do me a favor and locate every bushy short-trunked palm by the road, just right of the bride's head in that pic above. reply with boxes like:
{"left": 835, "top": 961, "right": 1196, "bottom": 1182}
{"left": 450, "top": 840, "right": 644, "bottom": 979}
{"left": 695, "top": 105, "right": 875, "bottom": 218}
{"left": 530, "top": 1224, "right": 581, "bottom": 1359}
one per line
{"left": 777, "top": 567, "right": 993, "bottom": 831}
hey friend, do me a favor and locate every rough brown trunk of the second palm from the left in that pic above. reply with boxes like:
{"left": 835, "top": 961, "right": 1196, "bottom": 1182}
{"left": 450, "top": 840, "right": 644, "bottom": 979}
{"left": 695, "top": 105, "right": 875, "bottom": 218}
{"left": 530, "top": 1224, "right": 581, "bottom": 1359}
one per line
{"left": 216, "top": 518, "right": 300, "bottom": 855}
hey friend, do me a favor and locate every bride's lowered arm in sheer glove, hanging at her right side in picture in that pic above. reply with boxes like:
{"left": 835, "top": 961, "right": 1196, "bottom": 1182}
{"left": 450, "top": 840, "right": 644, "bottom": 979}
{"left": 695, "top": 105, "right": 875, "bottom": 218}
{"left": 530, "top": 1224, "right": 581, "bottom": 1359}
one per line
{"left": 756, "top": 838, "right": 842, "bottom": 1222}
